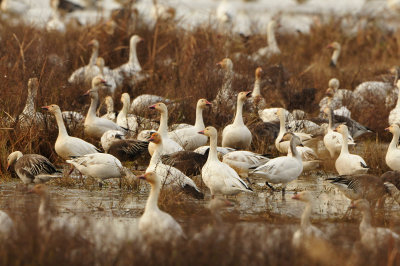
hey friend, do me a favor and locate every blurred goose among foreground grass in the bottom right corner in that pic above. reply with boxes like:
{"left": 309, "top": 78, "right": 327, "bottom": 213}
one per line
{"left": 352, "top": 199, "right": 400, "bottom": 252}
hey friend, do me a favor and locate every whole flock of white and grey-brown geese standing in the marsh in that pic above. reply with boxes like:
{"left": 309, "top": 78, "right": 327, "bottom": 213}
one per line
{"left": 0, "top": 29, "right": 400, "bottom": 254}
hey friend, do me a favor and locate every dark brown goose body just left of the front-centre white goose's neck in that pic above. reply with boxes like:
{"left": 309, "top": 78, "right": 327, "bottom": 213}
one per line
{"left": 161, "top": 150, "right": 210, "bottom": 176}
